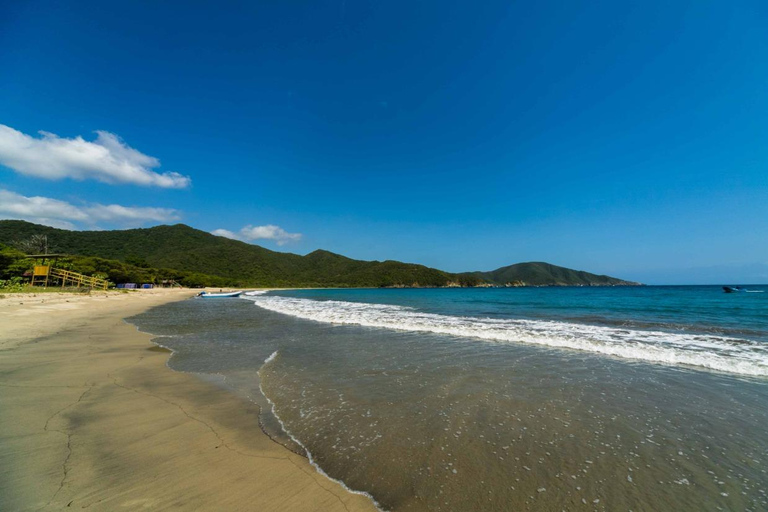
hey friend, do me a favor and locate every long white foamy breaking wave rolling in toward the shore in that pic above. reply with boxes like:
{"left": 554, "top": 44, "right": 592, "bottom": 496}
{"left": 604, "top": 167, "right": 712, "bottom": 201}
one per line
{"left": 243, "top": 295, "right": 768, "bottom": 377}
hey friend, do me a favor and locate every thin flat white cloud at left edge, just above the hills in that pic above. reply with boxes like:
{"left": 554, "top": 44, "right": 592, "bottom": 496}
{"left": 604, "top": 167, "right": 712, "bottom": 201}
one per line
{"left": 0, "top": 189, "right": 180, "bottom": 229}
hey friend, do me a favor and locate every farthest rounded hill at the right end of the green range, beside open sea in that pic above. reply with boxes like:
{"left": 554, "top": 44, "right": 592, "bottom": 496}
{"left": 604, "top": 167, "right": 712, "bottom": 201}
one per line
{"left": 465, "top": 261, "right": 639, "bottom": 286}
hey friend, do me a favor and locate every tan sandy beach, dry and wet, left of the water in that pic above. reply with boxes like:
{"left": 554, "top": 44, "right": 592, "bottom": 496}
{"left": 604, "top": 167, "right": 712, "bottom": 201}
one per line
{"left": 0, "top": 290, "right": 375, "bottom": 512}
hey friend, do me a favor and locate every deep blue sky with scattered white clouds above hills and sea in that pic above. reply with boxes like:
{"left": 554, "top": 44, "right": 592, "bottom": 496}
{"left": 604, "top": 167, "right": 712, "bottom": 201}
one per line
{"left": 0, "top": 0, "right": 768, "bottom": 283}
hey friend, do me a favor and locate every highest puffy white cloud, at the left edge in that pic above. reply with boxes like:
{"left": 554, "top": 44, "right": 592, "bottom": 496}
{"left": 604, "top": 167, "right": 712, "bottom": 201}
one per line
{"left": 0, "top": 124, "right": 190, "bottom": 188}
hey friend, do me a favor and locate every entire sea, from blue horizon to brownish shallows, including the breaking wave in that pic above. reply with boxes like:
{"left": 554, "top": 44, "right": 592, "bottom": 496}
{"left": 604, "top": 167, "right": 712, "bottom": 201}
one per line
{"left": 132, "top": 287, "right": 768, "bottom": 511}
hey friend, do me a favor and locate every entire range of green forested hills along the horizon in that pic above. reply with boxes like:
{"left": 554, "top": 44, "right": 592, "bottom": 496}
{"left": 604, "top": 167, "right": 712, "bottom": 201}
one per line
{"left": 0, "top": 220, "right": 632, "bottom": 287}
